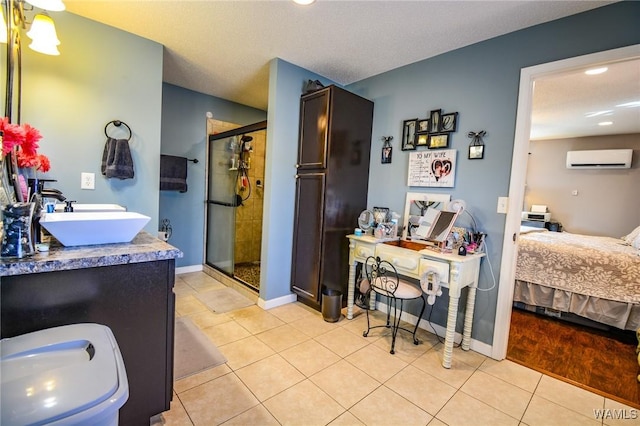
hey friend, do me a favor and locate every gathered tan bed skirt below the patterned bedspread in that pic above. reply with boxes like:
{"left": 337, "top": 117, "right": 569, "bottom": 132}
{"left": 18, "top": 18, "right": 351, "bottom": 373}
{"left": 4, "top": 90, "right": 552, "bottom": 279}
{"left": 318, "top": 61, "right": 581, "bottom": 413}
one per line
{"left": 513, "top": 280, "right": 640, "bottom": 331}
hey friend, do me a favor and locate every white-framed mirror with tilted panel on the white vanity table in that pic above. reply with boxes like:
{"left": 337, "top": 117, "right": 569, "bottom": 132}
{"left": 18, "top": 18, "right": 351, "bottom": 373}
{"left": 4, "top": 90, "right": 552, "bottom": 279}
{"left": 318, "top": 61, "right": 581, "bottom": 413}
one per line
{"left": 402, "top": 192, "right": 457, "bottom": 244}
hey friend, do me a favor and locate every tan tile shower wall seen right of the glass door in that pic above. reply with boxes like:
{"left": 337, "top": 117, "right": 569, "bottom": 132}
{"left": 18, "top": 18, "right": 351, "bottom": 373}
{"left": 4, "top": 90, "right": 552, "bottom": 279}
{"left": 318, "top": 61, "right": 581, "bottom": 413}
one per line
{"left": 235, "top": 130, "right": 267, "bottom": 263}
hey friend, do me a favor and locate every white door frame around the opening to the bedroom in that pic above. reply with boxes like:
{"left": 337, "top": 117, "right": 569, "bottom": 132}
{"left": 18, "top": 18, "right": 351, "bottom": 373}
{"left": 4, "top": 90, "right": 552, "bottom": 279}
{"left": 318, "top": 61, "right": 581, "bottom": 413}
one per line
{"left": 491, "top": 44, "right": 640, "bottom": 360}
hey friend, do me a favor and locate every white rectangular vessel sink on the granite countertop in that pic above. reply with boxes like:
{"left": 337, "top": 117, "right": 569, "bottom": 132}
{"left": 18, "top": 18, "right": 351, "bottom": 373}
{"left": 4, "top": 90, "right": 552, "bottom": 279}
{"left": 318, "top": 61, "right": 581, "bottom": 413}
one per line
{"left": 40, "top": 211, "right": 151, "bottom": 246}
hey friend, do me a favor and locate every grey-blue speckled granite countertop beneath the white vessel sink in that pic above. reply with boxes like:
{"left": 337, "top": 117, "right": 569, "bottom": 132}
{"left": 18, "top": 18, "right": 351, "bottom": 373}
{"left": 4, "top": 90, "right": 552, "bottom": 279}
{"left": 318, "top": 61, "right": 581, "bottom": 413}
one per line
{"left": 0, "top": 231, "right": 182, "bottom": 276}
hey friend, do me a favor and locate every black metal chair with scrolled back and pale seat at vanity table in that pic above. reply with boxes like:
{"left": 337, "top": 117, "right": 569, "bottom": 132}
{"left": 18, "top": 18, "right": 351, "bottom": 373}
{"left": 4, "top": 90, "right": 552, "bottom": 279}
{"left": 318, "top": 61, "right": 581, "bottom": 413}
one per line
{"left": 359, "top": 256, "right": 426, "bottom": 354}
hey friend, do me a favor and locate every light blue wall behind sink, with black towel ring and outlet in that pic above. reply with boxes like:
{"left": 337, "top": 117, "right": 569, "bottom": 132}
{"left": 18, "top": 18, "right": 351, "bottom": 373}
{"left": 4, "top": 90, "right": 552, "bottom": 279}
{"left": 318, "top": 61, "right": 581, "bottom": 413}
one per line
{"left": 21, "top": 12, "right": 162, "bottom": 234}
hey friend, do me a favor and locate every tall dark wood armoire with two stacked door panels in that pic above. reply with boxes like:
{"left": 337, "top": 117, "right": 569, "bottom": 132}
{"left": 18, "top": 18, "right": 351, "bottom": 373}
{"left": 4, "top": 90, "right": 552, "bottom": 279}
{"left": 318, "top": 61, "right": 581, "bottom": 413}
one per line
{"left": 291, "top": 86, "right": 373, "bottom": 310}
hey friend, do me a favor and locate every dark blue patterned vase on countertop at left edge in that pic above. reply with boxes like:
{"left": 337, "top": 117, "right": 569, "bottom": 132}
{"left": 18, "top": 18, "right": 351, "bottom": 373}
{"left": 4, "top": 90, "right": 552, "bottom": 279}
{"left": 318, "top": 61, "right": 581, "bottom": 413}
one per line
{"left": 0, "top": 203, "right": 35, "bottom": 258}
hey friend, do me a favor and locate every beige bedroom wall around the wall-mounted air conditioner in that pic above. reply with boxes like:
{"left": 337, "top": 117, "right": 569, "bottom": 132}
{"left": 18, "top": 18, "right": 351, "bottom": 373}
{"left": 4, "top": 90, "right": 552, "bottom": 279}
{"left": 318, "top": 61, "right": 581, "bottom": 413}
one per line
{"left": 524, "top": 134, "right": 640, "bottom": 238}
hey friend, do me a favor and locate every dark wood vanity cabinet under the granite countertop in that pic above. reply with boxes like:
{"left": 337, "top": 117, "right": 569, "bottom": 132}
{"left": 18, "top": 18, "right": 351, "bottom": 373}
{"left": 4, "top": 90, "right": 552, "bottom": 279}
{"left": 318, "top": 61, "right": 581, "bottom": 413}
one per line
{"left": 0, "top": 260, "right": 175, "bottom": 426}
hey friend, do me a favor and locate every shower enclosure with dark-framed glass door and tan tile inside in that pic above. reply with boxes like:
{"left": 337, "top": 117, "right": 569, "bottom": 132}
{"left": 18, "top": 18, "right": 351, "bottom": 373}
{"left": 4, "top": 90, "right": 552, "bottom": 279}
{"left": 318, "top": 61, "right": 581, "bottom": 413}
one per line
{"left": 205, "top": 121, "right": 267, "bottom": 290}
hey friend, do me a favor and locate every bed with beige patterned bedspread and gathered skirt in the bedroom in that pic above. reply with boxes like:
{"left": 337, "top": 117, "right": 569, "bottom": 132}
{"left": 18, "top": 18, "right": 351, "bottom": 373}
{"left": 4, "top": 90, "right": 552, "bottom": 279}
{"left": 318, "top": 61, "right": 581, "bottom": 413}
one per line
{"left": 514, "top": 228, "right": 640, "bottom": 331}
